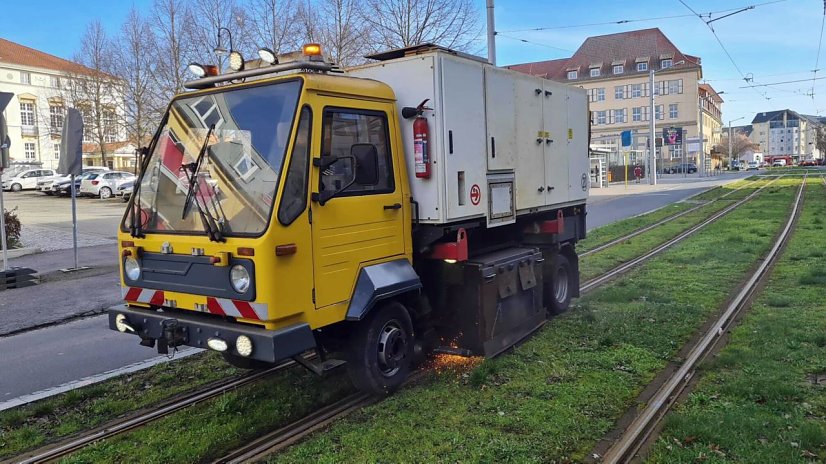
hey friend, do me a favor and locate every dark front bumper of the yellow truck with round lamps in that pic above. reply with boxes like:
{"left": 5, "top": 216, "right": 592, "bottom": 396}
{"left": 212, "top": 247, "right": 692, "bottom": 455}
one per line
{"left": 108, "top": 305, "right": 316, "bottom": 363}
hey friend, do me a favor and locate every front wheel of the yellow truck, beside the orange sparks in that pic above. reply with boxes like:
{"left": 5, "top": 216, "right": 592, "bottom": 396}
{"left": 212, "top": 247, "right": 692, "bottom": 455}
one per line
{"left": 347, "top": 302, "right": 414, "bottom": 395}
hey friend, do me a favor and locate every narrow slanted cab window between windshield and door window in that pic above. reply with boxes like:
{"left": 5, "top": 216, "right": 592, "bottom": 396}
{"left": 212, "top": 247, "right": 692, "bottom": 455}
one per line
{"left": 278, "top": 107, "right": 312, "bottom": 226}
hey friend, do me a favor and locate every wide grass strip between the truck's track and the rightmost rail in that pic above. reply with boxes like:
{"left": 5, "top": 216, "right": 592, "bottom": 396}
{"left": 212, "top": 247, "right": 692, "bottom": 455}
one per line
{"left": 260, "top": 181, "right": 796, "bottom": 463}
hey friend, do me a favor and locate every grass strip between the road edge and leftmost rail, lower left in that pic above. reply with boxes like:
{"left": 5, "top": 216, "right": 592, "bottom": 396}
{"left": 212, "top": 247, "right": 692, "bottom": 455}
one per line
{"left": 0, "top": 353, "right": 241, "bottom": 458}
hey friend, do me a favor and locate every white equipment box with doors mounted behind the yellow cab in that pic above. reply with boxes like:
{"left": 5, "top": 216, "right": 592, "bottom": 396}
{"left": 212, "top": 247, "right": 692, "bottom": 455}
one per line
{"left": 347, "top": 47, "right": 590, "bottom": 227}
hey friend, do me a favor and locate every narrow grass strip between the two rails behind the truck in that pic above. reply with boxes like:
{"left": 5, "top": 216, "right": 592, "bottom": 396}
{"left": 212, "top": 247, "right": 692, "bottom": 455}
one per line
{"left": 580, "top": 180, "right": 771, "bottom": 282}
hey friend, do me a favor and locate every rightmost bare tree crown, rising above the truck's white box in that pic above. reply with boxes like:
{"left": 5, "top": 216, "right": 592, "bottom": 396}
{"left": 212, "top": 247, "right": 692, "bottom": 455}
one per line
{"left": 362, "top": 0, "right": 481, "bottom": 51}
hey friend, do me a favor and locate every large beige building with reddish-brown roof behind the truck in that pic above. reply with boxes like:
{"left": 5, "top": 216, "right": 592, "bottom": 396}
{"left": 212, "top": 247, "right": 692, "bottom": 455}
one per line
{"left": 508, "top": 29, "right": 723, "bottom": 171}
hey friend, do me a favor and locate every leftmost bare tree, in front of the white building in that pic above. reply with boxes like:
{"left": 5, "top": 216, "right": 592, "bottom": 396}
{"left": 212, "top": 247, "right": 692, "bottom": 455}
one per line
{"left": 66, "top": 20, "right": 124, "bottom": 166}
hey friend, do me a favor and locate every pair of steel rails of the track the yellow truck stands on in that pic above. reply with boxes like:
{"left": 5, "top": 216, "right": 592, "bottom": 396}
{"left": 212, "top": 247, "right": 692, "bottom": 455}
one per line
{"left": 11, "top": 176, "right": 782, "bottom": 464}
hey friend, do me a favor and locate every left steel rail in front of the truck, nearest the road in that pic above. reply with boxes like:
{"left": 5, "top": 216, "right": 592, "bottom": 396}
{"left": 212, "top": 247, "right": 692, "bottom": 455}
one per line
{"left": 13, "top": 360, "right": 297, "bottom": 464}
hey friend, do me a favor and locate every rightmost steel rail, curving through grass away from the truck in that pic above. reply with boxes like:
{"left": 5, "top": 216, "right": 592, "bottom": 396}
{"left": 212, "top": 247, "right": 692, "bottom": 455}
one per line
{"left": 602, "top": 174, "right": 807, "bottom": 463}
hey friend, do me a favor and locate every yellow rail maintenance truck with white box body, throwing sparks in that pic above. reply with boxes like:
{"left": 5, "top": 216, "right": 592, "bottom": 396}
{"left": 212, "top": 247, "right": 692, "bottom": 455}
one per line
{"left": 109, "top": 44, "right": 590, "bottom": 393}
